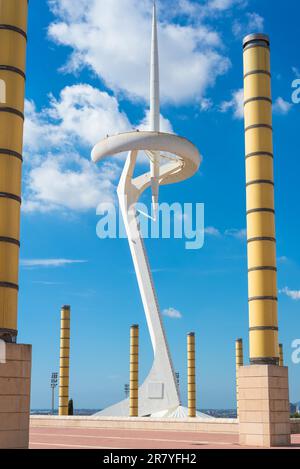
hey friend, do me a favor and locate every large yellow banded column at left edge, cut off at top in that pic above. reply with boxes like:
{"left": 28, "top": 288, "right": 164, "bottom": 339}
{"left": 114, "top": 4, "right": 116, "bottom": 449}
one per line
{"left": 0, "top": 0, "right": 28, "bottom": 342}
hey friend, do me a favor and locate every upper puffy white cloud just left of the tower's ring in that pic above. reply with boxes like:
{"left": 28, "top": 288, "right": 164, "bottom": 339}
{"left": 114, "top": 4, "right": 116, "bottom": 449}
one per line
{"left": 24, "top": 84, "right": 131, "bottom": 152}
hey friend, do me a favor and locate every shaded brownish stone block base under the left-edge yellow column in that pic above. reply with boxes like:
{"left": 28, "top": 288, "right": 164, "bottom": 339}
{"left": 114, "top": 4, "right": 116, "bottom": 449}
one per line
{"left": 0, "top": 341, "right": 31, "bottom": 449}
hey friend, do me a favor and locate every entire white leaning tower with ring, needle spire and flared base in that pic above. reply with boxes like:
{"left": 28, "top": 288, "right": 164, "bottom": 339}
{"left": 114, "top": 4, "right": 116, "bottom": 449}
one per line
{"left": 92, "top": 2, "right": 200, "bottom": 417}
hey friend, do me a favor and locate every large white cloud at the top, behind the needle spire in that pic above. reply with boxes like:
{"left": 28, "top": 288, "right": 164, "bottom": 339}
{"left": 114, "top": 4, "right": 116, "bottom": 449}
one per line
{"left": 49, "top": 0, "right": 230, "bottom": 104}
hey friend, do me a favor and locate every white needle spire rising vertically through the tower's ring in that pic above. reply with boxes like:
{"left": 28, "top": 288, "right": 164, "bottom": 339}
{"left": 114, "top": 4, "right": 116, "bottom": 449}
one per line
{"left": 150, "top": 1, "right": 160, "bottom": 219}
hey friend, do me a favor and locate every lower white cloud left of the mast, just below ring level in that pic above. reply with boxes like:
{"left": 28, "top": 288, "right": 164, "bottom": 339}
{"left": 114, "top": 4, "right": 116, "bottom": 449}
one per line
{"left": 23, "top": 153, "right": 121, "bottom": 212}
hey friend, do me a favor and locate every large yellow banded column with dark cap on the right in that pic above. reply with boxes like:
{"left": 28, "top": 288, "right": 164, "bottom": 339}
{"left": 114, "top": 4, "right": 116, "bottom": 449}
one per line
{"left": 244, "top": 34, "right": 279, "bottom": 365}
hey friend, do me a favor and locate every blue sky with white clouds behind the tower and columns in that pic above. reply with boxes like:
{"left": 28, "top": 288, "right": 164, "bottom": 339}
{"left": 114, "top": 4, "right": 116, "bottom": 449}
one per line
{"left": 18, "top": 0, "right": 300, "bottom": 408}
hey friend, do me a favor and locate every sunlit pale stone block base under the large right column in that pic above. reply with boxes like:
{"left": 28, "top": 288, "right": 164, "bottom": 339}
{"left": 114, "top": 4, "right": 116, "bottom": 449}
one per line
{"left": 238, "top": 365, "right": 291, "bottom": 448}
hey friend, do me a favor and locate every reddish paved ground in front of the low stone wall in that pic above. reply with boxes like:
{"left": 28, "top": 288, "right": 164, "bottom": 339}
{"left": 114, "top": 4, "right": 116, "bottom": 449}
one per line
{"left": 29, "top": 427, "right": 300, "bottom": 450}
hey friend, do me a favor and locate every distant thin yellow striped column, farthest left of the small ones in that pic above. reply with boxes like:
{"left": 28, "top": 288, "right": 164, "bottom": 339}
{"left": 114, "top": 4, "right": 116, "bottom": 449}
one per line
{"left": 59, "top": 306, "right": 71, "bottom": 415}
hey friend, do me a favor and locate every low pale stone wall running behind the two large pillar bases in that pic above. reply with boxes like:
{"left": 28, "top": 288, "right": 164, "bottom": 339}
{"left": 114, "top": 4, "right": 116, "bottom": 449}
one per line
{"left": 30, "top": 415, "right": 300, "bottom": 434}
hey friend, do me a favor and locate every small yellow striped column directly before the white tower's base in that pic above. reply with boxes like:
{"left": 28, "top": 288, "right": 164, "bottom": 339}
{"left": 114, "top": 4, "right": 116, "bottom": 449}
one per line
{"left": 129, "top": 324, "right": 139, "bottom": 417}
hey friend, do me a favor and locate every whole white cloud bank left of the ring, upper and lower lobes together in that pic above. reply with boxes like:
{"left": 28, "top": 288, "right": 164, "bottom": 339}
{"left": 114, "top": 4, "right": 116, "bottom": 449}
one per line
{"left": 22, "top": 84, "right": 172, "bottom": 212}
